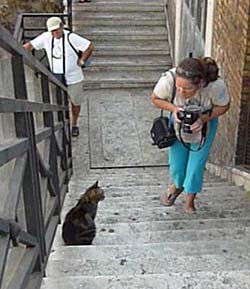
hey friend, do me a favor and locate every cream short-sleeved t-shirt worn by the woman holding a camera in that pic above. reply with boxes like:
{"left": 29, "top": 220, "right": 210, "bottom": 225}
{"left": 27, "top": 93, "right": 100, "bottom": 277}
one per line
{"left": 154, "top": 68, "right": 230, "bottom": 143}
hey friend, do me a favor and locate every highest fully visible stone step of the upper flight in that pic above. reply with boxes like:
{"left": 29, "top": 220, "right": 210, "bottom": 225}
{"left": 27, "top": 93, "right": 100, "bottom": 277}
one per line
{"left": 72, "top": 1, "right": 164, "bottom": 15}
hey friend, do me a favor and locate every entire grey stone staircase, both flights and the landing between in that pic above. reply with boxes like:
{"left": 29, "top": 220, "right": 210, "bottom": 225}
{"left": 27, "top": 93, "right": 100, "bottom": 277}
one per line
{"left": 41, "top": 0, "right": 250, "bottom": 289}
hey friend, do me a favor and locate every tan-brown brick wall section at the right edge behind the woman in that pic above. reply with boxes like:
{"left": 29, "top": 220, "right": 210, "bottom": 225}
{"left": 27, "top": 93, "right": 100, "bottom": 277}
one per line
{"left": 209, "top": 0, "right": 250, "bottom": 166}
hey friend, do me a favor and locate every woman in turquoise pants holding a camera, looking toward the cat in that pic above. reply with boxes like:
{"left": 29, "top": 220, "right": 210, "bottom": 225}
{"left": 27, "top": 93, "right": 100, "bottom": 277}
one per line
{"left": 151, "top": 57, "right": 230, "bottom": 213}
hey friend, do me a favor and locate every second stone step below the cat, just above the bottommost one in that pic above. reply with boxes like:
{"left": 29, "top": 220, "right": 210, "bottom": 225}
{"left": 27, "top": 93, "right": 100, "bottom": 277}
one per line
{"left": 47, "top": 252, "right": 250, "bottom": 278}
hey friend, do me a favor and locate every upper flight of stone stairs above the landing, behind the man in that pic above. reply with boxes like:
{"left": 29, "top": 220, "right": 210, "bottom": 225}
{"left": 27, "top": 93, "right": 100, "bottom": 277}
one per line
{"left": 73, "top": 0, "right": 171, "bottom": 89}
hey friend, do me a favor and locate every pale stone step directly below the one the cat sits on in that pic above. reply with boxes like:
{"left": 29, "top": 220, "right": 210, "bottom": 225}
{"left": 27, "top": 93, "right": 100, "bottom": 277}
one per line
{"left": 49, "top": 240, "right": 250, "bottom": 261}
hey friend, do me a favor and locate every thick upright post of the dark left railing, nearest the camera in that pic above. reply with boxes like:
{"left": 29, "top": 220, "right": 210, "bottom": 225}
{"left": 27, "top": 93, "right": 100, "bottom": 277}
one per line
{"left": 12, "top": 56, "right": 46, "bottom": 271}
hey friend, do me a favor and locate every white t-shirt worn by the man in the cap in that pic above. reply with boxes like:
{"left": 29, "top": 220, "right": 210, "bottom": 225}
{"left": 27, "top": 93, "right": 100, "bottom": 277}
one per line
{"left": 31, "top": 30, "right": 91, "bottom": 84}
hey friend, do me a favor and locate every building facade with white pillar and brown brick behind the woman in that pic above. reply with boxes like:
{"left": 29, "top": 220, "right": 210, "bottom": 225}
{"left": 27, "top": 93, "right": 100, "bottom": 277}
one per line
{"left": 166, "top": 0, "right": 250, "bottom": 186}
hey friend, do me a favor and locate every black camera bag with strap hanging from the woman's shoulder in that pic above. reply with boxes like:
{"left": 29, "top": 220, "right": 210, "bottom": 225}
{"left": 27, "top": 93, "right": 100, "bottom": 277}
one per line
{"left": 150, "top": 71, "right": 176, "bottom": 149}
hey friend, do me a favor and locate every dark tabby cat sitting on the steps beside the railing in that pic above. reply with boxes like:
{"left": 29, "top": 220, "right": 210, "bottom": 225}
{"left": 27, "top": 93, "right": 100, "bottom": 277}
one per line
{"left": 62, "top": 181, "right": 105, "bottom": 245}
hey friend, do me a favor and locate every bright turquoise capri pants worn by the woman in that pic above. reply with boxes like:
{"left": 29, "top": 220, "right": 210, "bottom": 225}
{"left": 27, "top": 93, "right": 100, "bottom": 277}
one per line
{"left": 169, "top": 118, "right": 218, "bottom": 194}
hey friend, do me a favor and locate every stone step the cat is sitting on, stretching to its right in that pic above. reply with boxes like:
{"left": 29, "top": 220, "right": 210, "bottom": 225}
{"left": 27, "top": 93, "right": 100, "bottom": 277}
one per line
{"left": 55, "top": 221, "right": 250, "bottom": 246}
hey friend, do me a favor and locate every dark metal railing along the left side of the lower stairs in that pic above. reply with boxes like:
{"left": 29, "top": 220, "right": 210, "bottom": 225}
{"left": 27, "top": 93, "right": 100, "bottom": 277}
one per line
{"left": 0, "top": 25, "right": 72, "bottom": 289}
